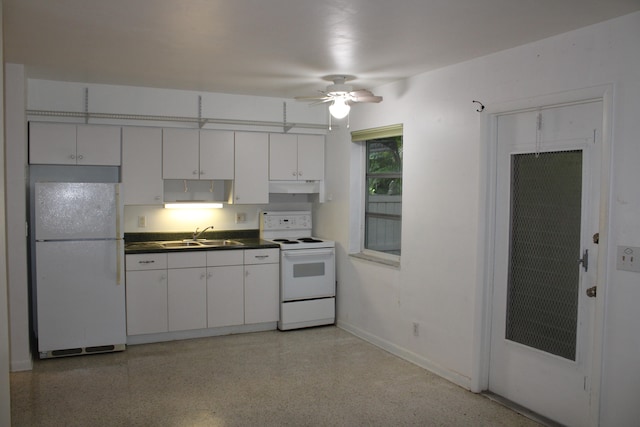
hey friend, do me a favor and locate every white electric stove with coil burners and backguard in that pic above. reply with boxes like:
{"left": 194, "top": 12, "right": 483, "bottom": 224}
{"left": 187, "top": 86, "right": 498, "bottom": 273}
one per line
{"left": 260, "top": 211, "right": 336, "bottom": 330}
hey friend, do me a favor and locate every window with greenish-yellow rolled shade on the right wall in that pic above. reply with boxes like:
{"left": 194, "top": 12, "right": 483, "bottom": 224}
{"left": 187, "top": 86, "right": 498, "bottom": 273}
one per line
{"left": 352, "top": 125, "right": 402, "bottom": 258}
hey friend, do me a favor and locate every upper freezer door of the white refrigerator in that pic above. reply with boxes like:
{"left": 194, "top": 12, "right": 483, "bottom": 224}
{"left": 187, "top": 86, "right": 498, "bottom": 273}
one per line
{"left": 34, "top": 182, "right": 122, "bottom": 240}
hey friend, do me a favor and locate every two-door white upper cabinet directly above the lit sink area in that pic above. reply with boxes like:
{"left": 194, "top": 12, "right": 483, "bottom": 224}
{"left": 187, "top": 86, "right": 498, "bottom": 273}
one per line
{"left": 162, "top": 128, "right": 234, "bottom": 180}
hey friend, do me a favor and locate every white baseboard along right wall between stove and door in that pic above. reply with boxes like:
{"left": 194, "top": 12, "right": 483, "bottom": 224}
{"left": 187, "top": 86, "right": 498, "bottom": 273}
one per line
{"left": 336, "top": 320, "right": 471, "bottom": 390}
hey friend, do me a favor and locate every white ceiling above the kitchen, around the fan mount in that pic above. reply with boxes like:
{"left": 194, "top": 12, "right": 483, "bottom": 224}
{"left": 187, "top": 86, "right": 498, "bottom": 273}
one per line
{"left": 3, "top": 0, "right": 640, "bottom": 98}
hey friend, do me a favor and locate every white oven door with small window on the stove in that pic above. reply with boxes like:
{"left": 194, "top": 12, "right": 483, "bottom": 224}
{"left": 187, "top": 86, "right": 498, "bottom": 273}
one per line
{"left": 280, "top": 248, "right": 336, "bottom": 301}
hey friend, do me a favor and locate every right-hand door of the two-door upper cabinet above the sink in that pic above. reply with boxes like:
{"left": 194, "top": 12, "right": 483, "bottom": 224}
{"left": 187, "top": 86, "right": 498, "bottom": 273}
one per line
{"left": 200, "top": 130, "right": 234, "bottom": 180}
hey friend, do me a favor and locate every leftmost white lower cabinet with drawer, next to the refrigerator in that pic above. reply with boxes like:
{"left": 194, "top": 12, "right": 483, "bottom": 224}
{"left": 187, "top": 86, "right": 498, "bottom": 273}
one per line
{"left": 126, "top": 254, "right": 169, "bottom": 335}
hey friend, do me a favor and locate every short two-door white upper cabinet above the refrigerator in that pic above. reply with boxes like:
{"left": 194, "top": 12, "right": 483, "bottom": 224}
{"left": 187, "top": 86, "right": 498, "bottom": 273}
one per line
{"left": 29, "top": 123, "right": 121, "bottom": 166}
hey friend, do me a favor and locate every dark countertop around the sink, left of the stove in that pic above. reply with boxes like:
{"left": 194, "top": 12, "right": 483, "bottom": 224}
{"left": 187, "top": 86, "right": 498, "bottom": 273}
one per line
{"left": 124, "top": 230, "right": 280, "bottom": 255}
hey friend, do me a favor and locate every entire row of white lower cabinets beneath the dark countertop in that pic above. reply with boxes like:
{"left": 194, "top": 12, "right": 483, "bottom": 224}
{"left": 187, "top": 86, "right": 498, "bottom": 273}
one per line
{"left": 126, "top": 248, "right": 280, "bottom": 335}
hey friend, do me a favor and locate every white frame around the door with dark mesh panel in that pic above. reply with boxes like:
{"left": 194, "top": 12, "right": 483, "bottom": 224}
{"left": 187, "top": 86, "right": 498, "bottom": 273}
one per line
{"left": 470, "top": 84, "right": 614, "bottom": 426}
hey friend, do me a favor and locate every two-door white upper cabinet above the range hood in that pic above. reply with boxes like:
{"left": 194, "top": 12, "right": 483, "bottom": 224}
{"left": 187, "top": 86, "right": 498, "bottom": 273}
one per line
{"left": 269, "top": 134, "right": 324, "bottom": 181}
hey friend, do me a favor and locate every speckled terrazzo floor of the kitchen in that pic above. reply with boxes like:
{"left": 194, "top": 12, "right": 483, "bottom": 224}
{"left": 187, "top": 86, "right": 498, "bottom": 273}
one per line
{"left": 11, "top": 327, "right": 538, "bottom": 427}
